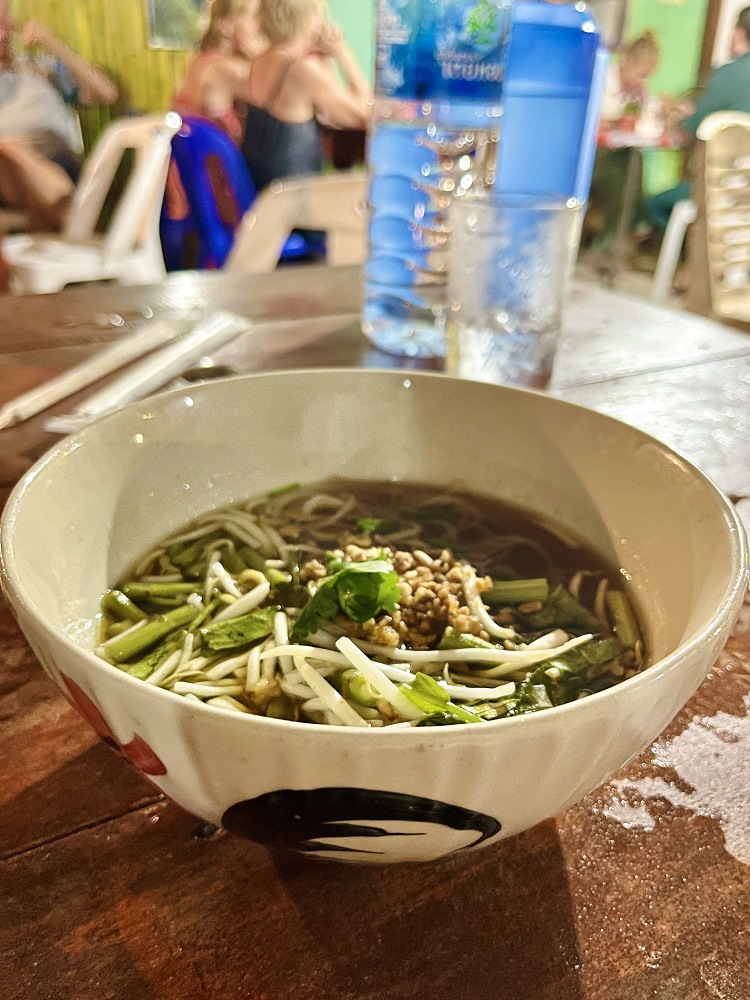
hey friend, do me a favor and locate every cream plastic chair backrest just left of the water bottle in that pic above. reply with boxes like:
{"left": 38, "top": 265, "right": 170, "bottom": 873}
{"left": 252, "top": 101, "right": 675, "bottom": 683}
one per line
{"left": 225, "top": 172, "right": 367, "bottom": 274}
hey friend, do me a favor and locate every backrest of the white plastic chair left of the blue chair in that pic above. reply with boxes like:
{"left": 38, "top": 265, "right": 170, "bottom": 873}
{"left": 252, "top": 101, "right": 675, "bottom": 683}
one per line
{"left": 63, "top": 112, "right": 181, "bottom": 257}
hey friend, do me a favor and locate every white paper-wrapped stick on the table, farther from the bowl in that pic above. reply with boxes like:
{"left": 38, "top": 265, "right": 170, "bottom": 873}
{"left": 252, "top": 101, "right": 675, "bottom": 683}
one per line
{"left": 0, "top": 319, "right": 187, "bottom": 430}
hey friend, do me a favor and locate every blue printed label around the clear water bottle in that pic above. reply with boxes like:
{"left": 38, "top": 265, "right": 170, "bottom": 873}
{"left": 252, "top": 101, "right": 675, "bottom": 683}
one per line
{"left": 375, "top": 0, "right": 510, "bottom": 104}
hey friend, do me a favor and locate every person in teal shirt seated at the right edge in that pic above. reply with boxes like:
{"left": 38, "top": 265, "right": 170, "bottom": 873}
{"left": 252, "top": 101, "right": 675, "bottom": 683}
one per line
{"left": 645, "top": 7, "right": 750, "bottom": 234}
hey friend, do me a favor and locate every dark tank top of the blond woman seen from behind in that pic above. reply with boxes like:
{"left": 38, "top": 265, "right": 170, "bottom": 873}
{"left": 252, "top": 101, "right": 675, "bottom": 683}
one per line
{"left": 242, "top": 61, "right": 323, "bottom": 191}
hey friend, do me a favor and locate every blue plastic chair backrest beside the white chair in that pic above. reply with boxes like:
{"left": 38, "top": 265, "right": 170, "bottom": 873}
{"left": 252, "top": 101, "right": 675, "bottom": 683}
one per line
{"left": 163, "top": 116, "right": 257, "bottom": 267}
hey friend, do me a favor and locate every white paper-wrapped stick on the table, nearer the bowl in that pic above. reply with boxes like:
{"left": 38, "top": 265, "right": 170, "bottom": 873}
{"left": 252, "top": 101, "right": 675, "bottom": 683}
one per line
{"left": 45, "top": 312, "right": 252, "bottom": 434}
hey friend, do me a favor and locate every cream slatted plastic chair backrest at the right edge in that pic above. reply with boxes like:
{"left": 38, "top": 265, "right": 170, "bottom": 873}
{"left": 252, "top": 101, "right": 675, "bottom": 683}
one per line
{"left": 698, "top": 111, "right": 750, "bottom": 319}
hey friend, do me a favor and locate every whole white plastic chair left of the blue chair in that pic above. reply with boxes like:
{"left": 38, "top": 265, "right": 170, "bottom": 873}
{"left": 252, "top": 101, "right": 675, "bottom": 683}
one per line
{"left": 3, "top": 112, "right": 182, "bottom": 294}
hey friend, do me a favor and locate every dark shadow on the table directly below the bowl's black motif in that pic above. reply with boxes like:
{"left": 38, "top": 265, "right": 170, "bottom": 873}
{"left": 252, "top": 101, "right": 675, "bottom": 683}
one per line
{"left": 270, "top": 820, "right": 583, "bottom": 1000}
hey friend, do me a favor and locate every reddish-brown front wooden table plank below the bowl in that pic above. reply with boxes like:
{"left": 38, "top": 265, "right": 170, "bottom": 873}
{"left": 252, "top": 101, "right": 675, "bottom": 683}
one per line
{"left": 0, "top": 608, "right": 750, "bottom": 1000}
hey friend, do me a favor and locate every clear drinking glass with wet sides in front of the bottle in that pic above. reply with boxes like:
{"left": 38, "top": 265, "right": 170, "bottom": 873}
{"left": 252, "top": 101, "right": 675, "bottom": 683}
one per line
{"left": 446, "top": 190, "right": 582, "bottom": 389}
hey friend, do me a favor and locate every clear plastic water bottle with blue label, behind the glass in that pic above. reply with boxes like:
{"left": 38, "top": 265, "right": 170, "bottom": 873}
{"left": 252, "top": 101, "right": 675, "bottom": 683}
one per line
{"left": 362, "top": 0, "right": 510, "bottom": 357}
